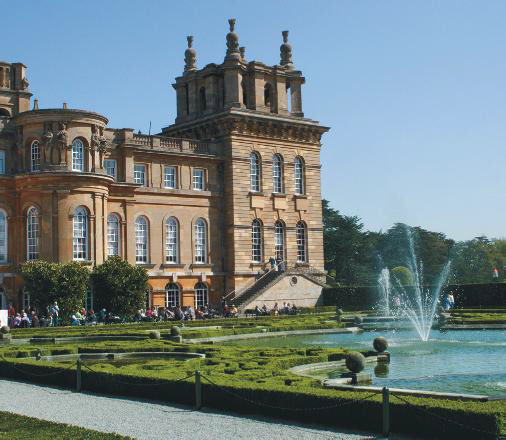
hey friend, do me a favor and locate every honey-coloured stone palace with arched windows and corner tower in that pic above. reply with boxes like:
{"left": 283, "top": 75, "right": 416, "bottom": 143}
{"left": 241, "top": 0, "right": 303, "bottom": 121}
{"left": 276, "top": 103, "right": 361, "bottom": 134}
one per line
{"left": 0, "top": 19, "right": 328, "bottom": 309}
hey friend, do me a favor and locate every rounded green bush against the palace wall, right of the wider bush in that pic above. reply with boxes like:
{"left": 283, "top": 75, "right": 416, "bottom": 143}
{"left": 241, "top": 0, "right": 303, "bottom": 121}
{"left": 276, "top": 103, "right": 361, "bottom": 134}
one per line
{"left": 91, "top": 257, "right": 148, "bottom": 316}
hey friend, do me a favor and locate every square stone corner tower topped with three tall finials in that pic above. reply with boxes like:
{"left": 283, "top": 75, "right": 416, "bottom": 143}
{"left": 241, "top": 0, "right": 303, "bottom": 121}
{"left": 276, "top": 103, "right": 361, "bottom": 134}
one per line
{"left": 161, "top": 19, "right": 329, "bottom": 304}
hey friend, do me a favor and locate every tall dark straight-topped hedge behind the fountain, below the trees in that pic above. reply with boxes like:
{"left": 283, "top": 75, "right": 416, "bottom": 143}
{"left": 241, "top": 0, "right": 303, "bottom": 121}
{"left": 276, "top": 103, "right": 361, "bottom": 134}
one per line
{"left": 323, "top": 283, "right": 506, "bottom": 310}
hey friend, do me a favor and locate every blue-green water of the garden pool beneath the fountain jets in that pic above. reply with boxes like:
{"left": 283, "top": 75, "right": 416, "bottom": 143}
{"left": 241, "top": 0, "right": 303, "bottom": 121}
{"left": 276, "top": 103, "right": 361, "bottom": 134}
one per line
{"left": 228, "top": 330, "right": 506, "bottom": 398}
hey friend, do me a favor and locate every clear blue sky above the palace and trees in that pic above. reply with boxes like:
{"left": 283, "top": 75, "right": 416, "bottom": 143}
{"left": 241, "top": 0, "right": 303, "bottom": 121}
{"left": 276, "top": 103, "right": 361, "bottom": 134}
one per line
{"left": 0, "top": 0, "right": 506, "bottom": 240}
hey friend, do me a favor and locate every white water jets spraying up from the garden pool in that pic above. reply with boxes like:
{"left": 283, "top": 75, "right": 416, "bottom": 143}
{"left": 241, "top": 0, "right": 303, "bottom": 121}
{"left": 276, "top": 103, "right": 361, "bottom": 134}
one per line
{"left": 378, "top": 227, "right": 451, "bottom": 341}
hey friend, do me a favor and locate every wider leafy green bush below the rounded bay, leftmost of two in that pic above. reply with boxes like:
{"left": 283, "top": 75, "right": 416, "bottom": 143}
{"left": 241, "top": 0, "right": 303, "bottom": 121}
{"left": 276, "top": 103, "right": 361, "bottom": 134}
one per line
{"left": 20, "top": 260, "right": 90, "bottom": 322}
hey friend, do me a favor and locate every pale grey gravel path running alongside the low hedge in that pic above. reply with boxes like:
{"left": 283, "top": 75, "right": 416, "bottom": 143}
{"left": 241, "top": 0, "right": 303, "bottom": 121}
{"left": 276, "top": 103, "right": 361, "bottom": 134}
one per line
{"left": 0, "top": 380, "right": 392, "bottom": 440}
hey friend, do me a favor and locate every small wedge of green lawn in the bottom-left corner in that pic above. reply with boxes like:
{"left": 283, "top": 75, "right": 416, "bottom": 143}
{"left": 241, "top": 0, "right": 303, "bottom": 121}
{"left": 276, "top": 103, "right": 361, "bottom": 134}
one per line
{"left": 0, "top": 411, "right": 130, "bottom": 440}
